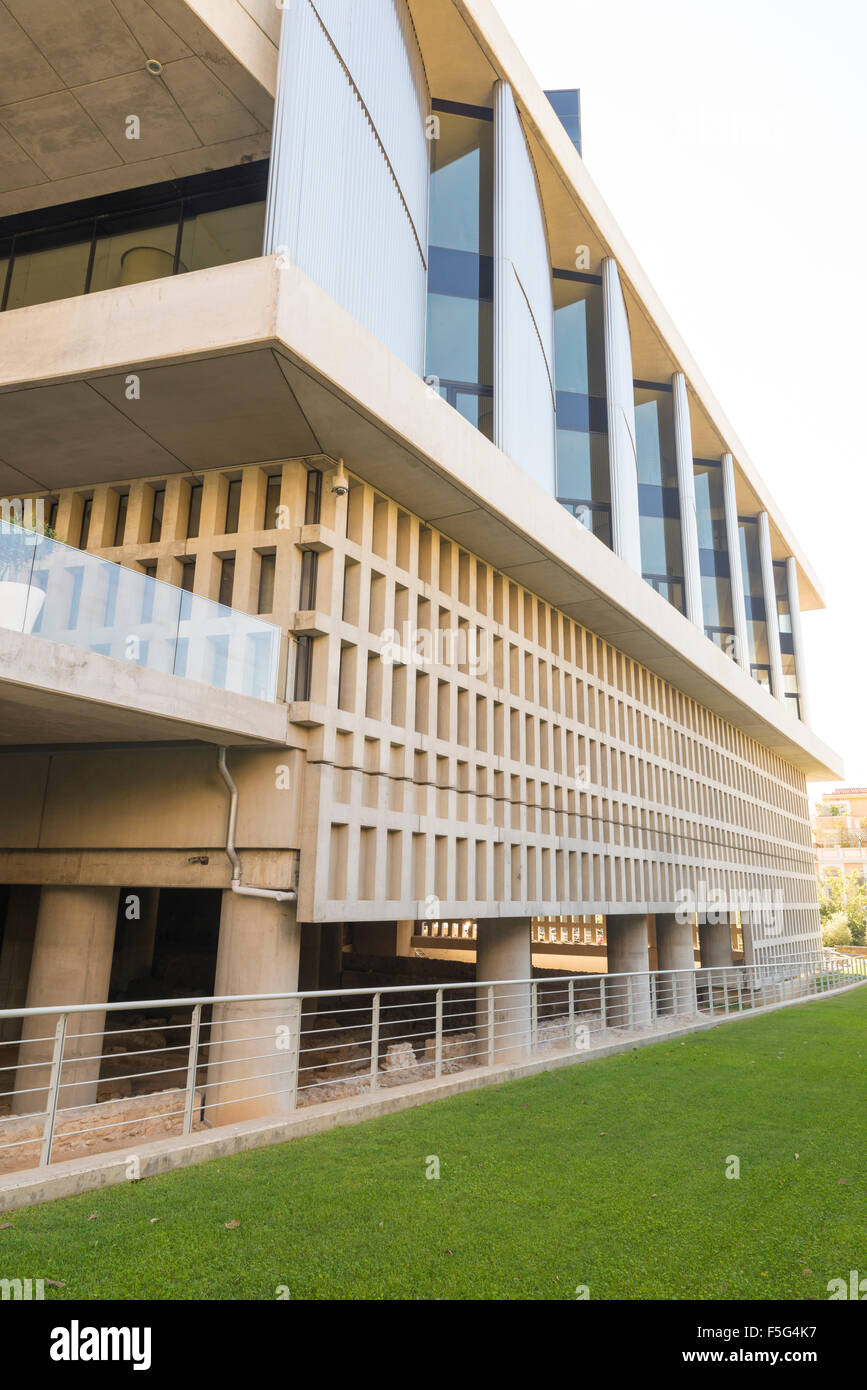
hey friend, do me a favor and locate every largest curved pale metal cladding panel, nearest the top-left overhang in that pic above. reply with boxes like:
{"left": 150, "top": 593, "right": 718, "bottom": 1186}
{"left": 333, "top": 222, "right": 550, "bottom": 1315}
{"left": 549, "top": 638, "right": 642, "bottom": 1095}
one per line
{"left": 265, "top": 0, "right": 429, "bottom": 374}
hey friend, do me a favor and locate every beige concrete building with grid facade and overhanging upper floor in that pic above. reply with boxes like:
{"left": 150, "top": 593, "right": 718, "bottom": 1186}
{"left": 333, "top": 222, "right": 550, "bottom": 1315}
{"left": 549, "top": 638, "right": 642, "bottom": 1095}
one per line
{"left": 0, "top": 0, "right": 838, "bottom": 1123}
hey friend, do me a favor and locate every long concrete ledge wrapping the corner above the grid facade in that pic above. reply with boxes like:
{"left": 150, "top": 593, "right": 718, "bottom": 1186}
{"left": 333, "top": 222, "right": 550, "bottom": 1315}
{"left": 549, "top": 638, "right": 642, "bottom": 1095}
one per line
{"left": 0, "top": 257, "right": 842, "bottom": 780}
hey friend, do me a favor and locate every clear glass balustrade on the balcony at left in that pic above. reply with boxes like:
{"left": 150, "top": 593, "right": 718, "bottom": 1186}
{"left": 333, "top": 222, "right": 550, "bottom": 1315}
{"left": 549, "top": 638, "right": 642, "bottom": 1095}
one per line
{"left": 0, "top": 521, "right": 281, "bottom": 701}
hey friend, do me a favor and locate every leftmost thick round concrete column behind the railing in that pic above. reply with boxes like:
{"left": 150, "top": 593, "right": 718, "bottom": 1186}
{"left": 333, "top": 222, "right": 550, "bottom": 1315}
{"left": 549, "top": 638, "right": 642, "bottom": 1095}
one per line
{"left": 13, "top": 885, "right": 119, "bottom": 1115}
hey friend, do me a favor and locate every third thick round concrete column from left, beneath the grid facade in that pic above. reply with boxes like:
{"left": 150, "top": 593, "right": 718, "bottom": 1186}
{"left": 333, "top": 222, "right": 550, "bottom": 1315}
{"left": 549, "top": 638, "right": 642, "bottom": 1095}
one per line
{"left": 475, "top": 917, "right": 532, "bottom": 1066}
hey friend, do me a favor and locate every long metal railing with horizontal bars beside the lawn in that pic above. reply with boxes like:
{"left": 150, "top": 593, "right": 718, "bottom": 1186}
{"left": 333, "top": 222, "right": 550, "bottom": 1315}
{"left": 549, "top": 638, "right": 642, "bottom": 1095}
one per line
{"left": 0, "top": 949, "right": 867, "bottom": 1176}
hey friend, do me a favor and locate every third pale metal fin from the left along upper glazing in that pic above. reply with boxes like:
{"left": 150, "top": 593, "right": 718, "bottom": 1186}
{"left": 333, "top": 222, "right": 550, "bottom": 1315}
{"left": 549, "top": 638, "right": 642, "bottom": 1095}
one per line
{"left": 602, "top": 257, "right": 642, "bottom": 574}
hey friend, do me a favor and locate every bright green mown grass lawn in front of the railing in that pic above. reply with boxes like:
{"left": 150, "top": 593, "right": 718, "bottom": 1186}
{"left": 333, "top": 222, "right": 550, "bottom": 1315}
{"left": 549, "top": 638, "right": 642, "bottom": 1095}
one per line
{"left": 0, "top": 990, "right": 867, "bottom": 1300}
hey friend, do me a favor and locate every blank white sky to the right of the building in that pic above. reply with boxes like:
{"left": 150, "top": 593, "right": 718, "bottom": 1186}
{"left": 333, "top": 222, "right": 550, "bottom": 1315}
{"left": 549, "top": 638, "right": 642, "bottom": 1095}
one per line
{"left": 495, "top": 0, "right": 867, "bottom": 792}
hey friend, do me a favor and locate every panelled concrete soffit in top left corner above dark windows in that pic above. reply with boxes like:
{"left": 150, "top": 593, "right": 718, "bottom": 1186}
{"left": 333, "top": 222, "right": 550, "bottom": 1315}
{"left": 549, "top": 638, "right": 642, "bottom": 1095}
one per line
{"left": 0, "top": 0, "right": 273, "bottom": 217}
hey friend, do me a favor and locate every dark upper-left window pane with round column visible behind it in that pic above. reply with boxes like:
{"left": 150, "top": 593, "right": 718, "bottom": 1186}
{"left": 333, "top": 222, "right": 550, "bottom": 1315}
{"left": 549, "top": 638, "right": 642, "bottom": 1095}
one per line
{"left": 89, "top": 203, "right": 180, "bottom": 293}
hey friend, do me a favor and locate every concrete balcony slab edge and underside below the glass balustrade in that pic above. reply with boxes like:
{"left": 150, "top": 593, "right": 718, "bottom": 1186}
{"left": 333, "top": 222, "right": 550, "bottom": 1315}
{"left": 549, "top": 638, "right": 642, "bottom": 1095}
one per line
{"left": 0, "top": 628, "right": 289, "bottom": 750}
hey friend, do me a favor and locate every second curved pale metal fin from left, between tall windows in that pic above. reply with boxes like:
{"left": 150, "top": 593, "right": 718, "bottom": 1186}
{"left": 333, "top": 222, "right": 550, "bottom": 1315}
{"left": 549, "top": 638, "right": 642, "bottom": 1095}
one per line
{"left": 493, "top": 82, "right": 557, "bottom": 496}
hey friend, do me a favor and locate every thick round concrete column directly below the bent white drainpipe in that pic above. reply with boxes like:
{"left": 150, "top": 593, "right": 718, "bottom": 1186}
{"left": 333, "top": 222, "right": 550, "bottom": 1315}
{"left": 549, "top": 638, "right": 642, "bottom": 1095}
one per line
{"left": 201, "top": 890, "right": 300, "bottom": 1125}
